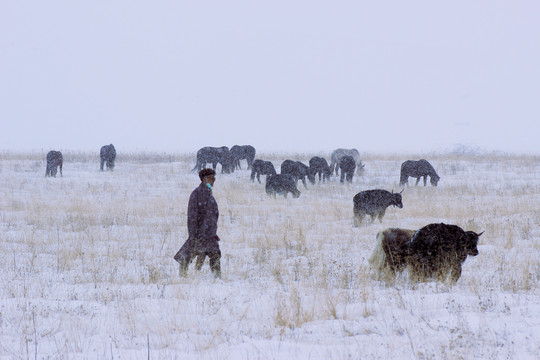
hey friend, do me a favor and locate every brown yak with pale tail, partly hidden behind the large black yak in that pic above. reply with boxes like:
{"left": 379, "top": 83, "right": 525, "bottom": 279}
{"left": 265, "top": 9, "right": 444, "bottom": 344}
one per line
{"left": 369, "top": 228, "right": 416, "bottom": 275}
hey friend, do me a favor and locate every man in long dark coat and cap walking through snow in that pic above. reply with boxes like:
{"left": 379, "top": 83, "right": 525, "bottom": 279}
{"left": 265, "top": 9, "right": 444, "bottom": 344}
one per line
{"left": 174, "top": 169, "right": 221, "bottom": 277}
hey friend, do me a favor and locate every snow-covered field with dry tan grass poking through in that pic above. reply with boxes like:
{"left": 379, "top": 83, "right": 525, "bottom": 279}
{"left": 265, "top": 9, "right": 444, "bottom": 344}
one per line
{"left": 0, "top": 151, "right": 540, "bottom": 359}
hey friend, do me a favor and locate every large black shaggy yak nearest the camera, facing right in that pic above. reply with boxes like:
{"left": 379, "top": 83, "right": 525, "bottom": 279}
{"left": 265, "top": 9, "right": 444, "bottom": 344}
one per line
{"left": 406, "top": 223, "right": 483, "bottom": 283}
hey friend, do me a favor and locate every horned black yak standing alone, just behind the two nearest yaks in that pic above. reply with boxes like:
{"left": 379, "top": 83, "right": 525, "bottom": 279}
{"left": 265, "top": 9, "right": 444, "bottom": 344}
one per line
{"left": 353, "top": 189, "right": 403, "bottom": 226}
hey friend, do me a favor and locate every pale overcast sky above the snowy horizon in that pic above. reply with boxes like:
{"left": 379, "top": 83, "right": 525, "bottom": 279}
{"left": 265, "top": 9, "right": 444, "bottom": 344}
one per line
{"left": 0, "top": 0, "right": 540, "bottom": 153}
